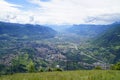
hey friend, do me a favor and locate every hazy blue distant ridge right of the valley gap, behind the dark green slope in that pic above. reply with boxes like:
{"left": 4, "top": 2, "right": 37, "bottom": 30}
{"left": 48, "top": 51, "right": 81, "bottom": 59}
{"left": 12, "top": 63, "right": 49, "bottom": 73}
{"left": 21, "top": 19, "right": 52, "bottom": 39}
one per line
{"left": 67, "top": 24, "right": 110, "bottom": 36}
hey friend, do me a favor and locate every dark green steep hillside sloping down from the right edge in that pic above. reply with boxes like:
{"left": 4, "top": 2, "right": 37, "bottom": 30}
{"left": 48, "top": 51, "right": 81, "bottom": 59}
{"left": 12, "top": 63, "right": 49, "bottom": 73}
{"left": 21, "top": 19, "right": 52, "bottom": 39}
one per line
{"left": 93, "top": 23, "right": 120, "bottom": 62}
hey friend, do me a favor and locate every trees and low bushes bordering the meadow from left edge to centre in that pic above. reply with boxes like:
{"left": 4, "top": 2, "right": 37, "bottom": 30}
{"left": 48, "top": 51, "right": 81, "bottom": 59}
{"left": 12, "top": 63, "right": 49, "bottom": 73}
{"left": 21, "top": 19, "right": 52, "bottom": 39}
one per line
{"left": 0, "top": 53, "right": 63, "bottom": 75}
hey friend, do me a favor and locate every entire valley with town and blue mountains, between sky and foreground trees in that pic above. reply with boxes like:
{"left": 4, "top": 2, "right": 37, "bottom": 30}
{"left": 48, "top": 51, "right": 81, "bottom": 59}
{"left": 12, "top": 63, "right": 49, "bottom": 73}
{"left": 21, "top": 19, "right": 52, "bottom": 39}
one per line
{"left": 0, "top": 22, "right": 120, "bottom": 70}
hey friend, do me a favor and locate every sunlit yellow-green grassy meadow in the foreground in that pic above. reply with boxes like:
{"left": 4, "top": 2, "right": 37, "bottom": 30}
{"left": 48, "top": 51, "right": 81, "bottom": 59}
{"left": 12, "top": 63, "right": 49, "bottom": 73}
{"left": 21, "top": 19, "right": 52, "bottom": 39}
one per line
{"left": 0, "top": 70, "right": 120, "bottom": 80}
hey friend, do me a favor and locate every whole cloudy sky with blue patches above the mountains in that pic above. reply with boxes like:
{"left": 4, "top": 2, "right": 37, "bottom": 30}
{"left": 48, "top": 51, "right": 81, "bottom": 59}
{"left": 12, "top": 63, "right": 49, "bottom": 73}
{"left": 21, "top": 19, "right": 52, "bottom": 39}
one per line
{"left": 0, "top": 0, "right": 120, "bottom": 25}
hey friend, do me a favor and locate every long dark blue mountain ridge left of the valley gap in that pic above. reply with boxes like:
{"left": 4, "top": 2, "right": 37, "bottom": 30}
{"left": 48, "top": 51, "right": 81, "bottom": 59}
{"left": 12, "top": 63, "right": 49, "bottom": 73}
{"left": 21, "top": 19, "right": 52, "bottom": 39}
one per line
{"left": 0, "top": 22, "right": 57, "bottom": 39}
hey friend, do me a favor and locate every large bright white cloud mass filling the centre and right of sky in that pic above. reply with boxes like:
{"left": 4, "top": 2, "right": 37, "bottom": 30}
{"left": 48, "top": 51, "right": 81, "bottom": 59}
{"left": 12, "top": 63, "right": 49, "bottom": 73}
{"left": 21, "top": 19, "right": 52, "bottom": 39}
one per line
{"left": 26, "top": 0, "right": 120, "bottom": 24}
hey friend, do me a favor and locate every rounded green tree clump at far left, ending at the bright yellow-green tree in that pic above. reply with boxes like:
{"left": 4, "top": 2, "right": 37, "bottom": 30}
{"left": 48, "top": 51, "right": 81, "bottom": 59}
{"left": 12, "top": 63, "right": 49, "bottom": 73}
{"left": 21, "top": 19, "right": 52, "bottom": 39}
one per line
{"left": 0, "top": 54, "right": 35, "bottom": 74}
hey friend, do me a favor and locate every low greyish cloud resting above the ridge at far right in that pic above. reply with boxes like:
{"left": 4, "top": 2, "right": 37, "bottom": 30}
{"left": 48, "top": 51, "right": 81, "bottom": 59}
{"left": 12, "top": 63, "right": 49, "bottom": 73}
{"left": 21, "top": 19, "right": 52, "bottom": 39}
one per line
{"left": 85, "top": 13, "right": 120, "bottom": 24}
